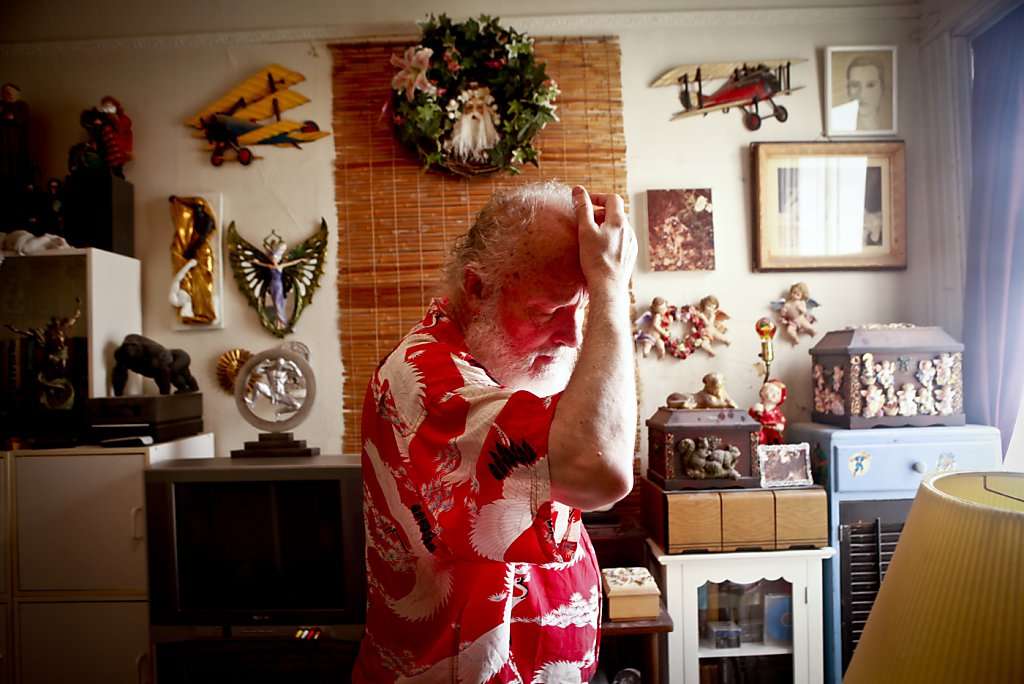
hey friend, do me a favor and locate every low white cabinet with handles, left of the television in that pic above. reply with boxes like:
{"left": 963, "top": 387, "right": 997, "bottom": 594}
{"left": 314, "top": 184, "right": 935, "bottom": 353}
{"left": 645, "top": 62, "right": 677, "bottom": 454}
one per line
{"left": 0, "top": 433, "right": 215, "bottom": 684}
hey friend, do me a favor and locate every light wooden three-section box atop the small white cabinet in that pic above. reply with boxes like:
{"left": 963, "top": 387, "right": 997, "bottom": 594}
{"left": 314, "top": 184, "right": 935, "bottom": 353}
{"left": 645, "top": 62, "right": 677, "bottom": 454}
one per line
{"left": 640, "top": 478, "right": 828, "bottom": 553}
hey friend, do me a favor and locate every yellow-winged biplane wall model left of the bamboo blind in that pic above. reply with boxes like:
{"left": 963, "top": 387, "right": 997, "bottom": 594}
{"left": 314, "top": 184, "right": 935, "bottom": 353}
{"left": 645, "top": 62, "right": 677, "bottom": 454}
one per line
{"left": 185, "top": 65, "right": 330, "bottom": 166}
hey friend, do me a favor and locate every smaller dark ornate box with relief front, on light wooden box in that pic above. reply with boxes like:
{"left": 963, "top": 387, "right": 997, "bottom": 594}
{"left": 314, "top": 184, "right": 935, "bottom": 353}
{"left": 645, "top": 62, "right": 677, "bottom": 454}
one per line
{"left": 647, "top": 407, "right": 761, "bottom": 489}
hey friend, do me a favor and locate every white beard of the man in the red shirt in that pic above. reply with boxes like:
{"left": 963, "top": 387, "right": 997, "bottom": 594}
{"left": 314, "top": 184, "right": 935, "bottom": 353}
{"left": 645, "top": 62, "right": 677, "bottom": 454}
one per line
{"left": 466, "top": 299, "right": 580, "bottom": 396}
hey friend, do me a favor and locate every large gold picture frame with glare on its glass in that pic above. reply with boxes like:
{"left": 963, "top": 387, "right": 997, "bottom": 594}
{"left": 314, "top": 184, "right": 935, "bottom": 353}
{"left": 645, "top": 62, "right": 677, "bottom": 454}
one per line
{"left": 751, "top": 140, "right": 906, "bottom": 271}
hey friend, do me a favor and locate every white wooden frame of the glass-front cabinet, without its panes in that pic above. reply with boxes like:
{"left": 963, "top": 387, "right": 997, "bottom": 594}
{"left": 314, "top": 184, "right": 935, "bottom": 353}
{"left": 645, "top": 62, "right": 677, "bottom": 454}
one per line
{"left": 647, "top": 540, "right": 835, "bottom": 684}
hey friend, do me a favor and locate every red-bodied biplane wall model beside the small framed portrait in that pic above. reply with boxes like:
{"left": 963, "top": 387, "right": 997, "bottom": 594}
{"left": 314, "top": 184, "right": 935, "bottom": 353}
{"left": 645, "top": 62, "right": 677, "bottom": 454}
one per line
{"left": 650, "top": 58, "right": 807, "bottom": 131}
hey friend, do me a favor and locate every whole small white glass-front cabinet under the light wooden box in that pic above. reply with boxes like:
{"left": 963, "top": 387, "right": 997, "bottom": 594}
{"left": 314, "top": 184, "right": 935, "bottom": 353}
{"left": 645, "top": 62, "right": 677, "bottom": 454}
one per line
{"left": 648, "top": 542, "right": 834, "bottom": 684}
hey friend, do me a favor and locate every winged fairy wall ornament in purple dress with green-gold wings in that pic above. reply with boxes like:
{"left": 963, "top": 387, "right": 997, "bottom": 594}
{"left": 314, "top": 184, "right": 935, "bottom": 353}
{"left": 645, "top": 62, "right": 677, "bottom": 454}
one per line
{"left": 227, "top": 218, "right": 328, "bottom": 337}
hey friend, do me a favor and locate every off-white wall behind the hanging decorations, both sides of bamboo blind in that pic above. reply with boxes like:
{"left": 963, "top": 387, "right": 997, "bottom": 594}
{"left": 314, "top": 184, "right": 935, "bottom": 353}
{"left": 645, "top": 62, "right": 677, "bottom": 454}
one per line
{"left": 0, "top": 2, "right": 929, "bottom": 455}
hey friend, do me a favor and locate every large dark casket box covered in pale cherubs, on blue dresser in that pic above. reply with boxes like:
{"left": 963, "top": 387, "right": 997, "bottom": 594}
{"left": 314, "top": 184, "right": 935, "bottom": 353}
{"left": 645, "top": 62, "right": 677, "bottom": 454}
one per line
{"left": 810, "top": 324, "right": 967, "bottom": 429}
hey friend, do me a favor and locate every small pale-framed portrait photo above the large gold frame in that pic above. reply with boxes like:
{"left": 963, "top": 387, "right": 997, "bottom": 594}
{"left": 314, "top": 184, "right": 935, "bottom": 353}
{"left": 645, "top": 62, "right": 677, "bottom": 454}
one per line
{"left": 824, "top": 45, "right": 898, "bottom": 136}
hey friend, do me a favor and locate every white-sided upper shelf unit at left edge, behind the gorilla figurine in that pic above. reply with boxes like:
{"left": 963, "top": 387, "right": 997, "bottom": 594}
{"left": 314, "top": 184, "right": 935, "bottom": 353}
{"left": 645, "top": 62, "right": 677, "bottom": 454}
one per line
{"left": 0, "top": 248, "right": 142, "bottom": 397}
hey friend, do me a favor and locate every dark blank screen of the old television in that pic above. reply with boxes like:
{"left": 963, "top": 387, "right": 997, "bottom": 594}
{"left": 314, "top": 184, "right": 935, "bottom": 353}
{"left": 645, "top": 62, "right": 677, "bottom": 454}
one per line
{"left": 174, "top": 480, "right": 347, "bottom": 611}
